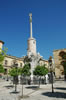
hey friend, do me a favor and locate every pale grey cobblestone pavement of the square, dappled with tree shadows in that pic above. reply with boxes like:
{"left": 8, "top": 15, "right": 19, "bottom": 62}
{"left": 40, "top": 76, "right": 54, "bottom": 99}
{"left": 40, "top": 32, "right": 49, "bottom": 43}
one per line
{"left": 0, "top": 80, "right": 66, "bottom": 100}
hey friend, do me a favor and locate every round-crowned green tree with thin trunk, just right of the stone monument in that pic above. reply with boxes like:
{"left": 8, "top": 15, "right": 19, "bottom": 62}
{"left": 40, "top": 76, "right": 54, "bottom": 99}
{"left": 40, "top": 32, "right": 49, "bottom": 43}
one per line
{"left": 33, "top": 65, "right": 48, "bottom": 87}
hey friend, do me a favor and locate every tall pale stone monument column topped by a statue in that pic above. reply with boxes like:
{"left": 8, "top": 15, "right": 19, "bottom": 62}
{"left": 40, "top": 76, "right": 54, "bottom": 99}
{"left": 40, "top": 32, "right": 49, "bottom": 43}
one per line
{"left": 27, "top": 13, "right": 38, "bottom": 83}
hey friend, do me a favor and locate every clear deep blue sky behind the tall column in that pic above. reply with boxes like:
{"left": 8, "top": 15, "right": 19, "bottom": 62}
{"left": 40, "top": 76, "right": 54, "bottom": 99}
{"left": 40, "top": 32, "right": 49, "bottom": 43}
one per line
{"left": 0, "top": 0, "right": 66, "bottom": 59}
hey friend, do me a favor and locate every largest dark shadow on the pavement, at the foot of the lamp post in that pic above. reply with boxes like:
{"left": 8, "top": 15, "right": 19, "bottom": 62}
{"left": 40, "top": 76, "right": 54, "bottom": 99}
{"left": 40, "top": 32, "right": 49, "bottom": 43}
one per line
{"left": 42, "top": 92, "right": 66, "bottom": 98}
